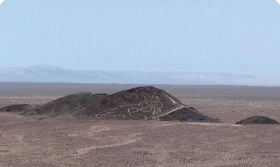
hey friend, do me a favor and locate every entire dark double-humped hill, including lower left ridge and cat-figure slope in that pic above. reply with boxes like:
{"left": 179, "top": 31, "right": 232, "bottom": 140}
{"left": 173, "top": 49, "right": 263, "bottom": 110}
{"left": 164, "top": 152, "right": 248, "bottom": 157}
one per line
{"left": 24, "top": 86, "right": 216, "bottom": 122}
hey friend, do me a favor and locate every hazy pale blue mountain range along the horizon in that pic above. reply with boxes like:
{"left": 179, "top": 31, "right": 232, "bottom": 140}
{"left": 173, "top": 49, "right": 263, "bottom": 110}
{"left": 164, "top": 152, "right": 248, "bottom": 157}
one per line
{"left": 0, "top": 66, "right": 280, "bottom": 86}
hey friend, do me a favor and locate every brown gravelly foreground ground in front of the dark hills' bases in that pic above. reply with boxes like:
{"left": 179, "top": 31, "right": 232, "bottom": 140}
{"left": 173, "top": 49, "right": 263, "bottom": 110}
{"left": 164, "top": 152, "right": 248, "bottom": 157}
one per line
{"left": 0, "top": 113, "right": 280, "bottom": 167}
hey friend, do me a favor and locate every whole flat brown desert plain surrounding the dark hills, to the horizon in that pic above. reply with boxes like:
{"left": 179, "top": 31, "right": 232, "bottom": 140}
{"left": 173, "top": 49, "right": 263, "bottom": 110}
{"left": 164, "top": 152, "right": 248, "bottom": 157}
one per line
{"left": 0, "top": 83, "right": 280, "bottom": 167}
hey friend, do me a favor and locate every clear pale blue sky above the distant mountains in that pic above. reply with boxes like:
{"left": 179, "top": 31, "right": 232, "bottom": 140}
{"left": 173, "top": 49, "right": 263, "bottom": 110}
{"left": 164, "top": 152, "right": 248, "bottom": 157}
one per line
{"left": 0, "top": 0, "right": 280, "bottom": 77}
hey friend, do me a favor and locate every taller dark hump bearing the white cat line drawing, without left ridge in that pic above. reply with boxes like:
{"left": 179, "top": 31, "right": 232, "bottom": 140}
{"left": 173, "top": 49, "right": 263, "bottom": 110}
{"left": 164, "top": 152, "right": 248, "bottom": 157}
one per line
{"left": 74, "top": 86, "right": 215, "bottom": 122}
